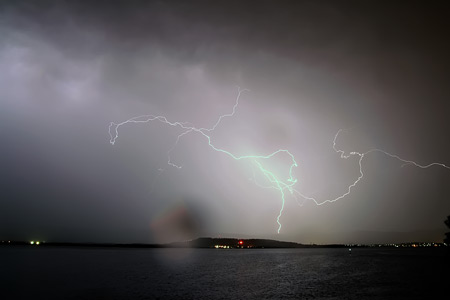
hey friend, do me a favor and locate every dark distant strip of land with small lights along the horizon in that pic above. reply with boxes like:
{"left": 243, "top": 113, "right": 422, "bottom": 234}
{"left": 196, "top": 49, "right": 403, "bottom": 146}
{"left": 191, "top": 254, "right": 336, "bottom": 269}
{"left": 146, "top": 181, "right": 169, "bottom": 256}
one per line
{"left": 0, "top": 237, "right": 448, "bottom": 249}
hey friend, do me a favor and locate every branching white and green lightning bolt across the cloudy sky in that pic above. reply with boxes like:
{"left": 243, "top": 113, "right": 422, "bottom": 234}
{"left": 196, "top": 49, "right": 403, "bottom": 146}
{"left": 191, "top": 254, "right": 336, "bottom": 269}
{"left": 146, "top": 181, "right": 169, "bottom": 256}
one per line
{"left": 108, "top": 87, "right": 450, "bottom": 233}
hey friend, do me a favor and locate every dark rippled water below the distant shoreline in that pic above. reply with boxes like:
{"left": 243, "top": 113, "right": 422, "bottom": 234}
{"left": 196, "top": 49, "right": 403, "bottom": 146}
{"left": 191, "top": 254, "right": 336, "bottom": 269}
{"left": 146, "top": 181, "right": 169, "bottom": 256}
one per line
{"left": 0, "top": 246, "right": 450, "bottom": 299}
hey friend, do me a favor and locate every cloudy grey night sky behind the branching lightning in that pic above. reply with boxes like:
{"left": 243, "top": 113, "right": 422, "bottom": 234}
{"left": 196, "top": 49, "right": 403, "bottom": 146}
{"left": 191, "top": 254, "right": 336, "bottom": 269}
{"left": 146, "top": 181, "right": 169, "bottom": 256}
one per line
{"left": 0, "top": 1, "right": 450, "bottom": 243}
